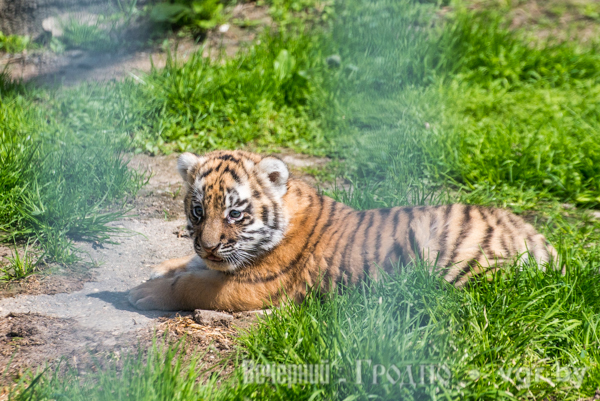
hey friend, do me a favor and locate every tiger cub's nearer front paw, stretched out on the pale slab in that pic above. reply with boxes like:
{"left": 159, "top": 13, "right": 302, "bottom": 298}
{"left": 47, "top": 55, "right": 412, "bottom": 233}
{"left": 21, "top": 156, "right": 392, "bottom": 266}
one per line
{"left": 128, "top": 278, "right": 180, "bottom": 310}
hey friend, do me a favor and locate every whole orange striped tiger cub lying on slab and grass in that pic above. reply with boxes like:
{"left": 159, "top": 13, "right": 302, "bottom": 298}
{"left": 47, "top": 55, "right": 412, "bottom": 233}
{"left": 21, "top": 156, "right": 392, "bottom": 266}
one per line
{"left": 129, "top": 151, "right": 557, "bottom": 311}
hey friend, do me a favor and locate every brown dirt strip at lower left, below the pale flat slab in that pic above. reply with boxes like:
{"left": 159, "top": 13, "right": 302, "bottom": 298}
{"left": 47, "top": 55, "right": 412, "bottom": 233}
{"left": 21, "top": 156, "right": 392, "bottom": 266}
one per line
{"left": 0, "top": 312, "right": 262, "bottom": 388}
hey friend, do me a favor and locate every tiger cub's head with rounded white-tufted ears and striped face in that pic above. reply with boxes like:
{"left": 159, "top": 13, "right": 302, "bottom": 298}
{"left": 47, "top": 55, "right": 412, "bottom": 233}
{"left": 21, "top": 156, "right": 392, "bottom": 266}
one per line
{"left": 177, "top": 151, "right": 289, "bottom": 272}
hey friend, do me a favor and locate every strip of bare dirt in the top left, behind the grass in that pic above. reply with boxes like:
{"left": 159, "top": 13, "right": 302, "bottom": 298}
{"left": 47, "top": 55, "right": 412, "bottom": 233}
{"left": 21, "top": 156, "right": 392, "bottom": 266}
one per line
{"left": 0, "top": 3, "right": 272, "bottom": 86}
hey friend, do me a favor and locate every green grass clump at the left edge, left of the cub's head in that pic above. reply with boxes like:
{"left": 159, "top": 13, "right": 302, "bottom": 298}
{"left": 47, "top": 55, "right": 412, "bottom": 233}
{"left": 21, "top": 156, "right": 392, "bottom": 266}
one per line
{"left": 0, "top": 82, "right": 143, "bottom": 263}
